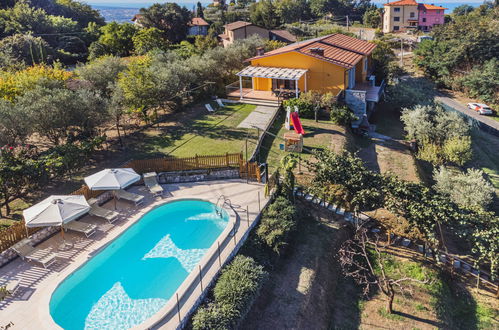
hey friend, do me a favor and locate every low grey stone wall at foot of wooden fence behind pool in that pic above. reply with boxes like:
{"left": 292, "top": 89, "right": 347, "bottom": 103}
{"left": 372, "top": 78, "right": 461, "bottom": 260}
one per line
{"left": 158, "top": 168, "right": 239, "bottom": 184}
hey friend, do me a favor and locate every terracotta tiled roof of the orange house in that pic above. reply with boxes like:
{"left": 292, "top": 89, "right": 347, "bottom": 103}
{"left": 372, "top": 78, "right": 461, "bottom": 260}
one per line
{"left": 248, "top": 34, "right": 376, "bottom": 69}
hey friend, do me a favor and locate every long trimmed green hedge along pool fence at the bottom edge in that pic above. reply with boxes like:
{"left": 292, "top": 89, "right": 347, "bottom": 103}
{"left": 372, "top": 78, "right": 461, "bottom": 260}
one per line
{"left": 192, "top": 255, "right": 267, "bottom": 330}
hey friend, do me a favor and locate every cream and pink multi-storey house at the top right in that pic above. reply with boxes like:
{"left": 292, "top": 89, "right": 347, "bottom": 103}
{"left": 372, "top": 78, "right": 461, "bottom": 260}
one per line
{"left": 383, "top": 0, "right": 446, "bottom": 33}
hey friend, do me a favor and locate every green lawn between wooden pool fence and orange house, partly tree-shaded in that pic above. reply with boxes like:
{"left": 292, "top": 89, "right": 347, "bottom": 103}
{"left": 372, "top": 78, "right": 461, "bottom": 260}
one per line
{"left": 127, "top": 104, "right": 256, "bottom": 158}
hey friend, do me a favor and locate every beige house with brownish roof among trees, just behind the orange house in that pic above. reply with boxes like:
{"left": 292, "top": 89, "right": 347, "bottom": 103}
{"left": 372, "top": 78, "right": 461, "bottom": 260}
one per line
{"left": 218, "top": 21, "right": 296, "bottom": 47}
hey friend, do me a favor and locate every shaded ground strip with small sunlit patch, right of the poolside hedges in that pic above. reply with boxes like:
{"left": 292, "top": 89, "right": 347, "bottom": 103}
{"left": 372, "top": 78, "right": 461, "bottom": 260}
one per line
{"left": 240, "top": 206, "right": 350, "bottom": 329}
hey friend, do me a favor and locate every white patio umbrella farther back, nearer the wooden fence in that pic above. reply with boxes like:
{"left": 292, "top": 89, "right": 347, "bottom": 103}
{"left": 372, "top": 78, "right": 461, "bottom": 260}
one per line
{"left": 85, "top": 168, "right": 140, "bottom": 209}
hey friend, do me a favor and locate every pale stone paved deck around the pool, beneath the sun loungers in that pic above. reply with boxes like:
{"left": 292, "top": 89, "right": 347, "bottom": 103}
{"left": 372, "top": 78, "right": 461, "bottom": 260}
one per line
{"left": 0, "top": 179, "right": 267, "bottom": 329}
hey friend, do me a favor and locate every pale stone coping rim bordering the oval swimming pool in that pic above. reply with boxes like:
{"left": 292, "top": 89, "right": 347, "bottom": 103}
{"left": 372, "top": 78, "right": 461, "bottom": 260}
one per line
{"left": 38, "top": 196, "right": 238, "bottom": 329}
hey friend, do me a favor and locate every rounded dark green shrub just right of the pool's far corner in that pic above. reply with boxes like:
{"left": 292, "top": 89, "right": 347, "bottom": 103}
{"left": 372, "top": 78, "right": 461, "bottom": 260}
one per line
{"left": 256, "top": 196, "right": 296, "bottom": 254}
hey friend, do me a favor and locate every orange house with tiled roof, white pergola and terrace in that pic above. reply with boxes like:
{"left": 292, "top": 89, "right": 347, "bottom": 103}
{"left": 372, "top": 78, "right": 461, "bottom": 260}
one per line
{"left": 227, "top": 34, "right": 384, "bottom": 127}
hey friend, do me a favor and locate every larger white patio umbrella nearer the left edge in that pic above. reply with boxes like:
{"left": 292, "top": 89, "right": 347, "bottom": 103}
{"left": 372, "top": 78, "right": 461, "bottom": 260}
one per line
{"left": 23, "top": 195, "right": 90, "bottom": 237}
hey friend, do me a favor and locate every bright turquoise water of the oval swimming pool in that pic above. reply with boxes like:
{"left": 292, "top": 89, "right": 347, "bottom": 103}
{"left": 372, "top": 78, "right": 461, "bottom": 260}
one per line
{"left": 50, "top": 200, "right": 229, "bottom": 330}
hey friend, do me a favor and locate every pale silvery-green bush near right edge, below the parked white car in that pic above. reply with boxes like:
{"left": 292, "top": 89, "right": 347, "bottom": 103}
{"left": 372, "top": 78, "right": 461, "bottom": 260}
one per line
{"left": 433, "top": 166, "right": 494, "bottom": 209}
